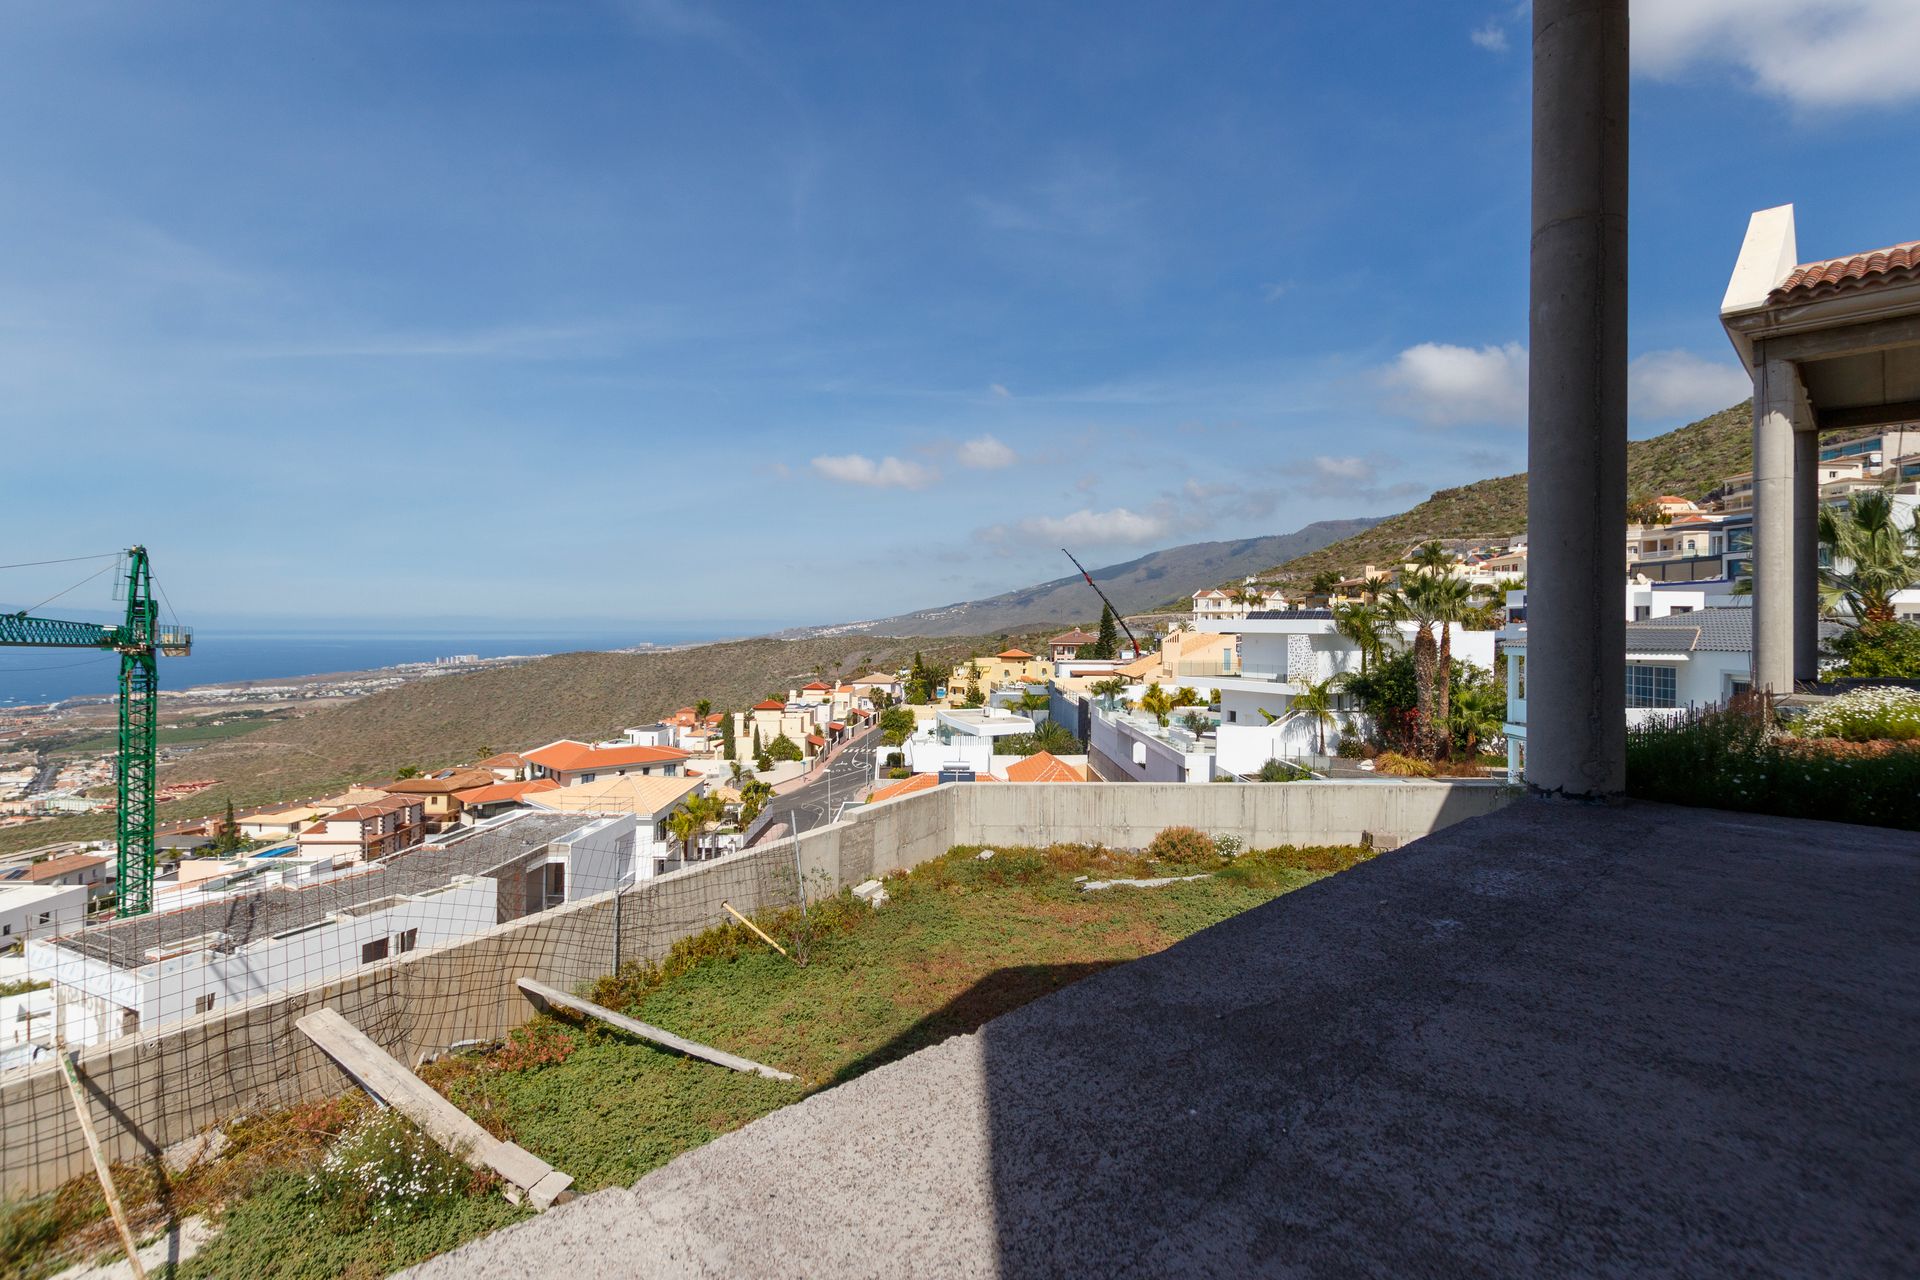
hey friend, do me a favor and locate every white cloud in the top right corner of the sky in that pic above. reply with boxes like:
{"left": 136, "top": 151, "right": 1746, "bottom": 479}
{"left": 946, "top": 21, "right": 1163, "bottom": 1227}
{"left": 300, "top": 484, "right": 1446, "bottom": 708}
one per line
{"left": 1632, "top": 0, "right": 1920, "bottom": 107}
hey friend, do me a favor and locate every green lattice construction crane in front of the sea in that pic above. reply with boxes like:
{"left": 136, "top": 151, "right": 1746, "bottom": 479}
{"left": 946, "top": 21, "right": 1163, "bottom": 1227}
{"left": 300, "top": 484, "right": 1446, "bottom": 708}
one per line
{"left": 0, "top": 547, "right": 194, "bottom": 915}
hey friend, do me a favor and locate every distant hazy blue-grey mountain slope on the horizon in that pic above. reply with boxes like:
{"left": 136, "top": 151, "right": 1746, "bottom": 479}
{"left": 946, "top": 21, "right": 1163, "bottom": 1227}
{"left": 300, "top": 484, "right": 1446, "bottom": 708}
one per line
{"left": 810, "top": 518, "right": 1373, "bottom": 635}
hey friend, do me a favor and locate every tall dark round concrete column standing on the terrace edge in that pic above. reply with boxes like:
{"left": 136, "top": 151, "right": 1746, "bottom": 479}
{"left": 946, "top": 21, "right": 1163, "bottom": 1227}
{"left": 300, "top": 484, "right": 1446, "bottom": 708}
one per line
{"left": 1526, "top": 0, "right": 1628, "bottom": 798}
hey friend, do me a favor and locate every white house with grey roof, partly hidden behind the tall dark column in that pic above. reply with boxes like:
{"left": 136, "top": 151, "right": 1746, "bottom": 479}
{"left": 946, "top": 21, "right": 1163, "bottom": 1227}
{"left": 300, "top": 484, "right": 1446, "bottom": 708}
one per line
{"left": 1500, "top": 606, "right": 1781, "bottom": 781}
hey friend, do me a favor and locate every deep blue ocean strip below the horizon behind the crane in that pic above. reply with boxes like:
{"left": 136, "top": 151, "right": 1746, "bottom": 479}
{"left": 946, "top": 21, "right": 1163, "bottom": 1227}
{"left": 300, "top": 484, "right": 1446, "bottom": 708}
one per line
{"left": 0, "top": 628, "right": 720, "bottom": 706}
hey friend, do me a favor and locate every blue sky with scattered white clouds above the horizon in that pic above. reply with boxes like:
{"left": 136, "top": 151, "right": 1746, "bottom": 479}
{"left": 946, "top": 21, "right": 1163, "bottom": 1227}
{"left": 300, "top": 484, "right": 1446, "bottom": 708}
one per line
{"left": 0, "top": 0, "right": 1920, "bottom": 629}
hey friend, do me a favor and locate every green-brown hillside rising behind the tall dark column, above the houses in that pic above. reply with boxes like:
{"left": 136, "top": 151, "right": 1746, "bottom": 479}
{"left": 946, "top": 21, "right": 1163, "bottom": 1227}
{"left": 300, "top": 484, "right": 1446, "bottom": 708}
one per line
{"left": 1267, "top": 403, "right": 1753, "bottom": 581}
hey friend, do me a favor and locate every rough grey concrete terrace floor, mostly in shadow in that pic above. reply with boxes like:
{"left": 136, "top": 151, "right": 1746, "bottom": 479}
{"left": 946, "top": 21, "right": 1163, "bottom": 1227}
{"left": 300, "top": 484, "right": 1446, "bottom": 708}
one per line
{"left": 411, "top": 800, "right": 1920, "bottom": 1280}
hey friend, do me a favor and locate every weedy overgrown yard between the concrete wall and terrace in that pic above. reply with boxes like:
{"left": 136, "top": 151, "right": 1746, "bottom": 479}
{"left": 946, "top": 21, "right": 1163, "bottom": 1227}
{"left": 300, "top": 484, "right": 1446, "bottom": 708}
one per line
{"left": 0, "top": 829, "right": 1371, "bottom": 1280}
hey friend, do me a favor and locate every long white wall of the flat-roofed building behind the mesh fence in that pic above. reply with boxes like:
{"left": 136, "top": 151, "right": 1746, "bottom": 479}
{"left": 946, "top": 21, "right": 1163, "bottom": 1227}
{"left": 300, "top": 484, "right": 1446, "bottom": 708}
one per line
{"left": 27, "top": 875, "right": 495, "bottom": 1044}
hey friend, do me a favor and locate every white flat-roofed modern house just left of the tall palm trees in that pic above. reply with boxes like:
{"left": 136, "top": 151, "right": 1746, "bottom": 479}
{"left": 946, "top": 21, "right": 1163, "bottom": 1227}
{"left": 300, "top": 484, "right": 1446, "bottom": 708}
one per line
{"left": 1198, "top": 608, "right": 1496, "bottom": 773}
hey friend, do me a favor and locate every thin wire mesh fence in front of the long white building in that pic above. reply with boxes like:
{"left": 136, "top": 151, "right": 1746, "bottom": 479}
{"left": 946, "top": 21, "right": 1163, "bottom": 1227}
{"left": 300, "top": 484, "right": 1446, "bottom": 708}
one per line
{"left": 0, "top": 814, "right": 825, "bottom": 1196}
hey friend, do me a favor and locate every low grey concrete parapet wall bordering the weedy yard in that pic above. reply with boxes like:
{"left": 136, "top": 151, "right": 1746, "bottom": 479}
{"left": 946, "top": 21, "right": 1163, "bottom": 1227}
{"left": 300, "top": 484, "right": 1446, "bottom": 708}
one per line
{"left": 0, "top": 783, "right": 1511, "bottom": 1197}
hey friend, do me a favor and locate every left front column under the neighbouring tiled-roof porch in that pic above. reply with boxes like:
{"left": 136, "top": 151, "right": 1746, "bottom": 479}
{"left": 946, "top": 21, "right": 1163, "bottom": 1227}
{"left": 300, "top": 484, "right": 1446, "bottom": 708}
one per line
{"left": 1753, "top": 361, "right": 1812, "bottom": 693}
